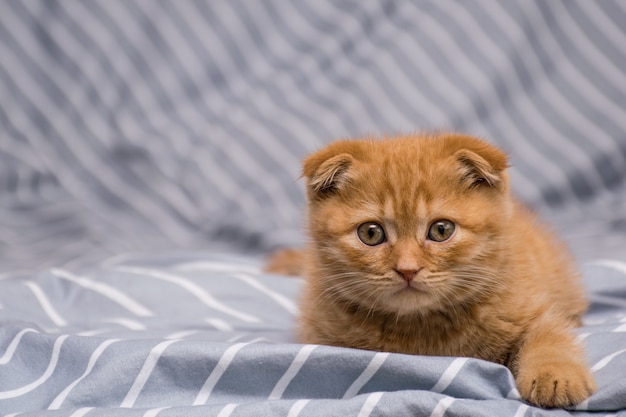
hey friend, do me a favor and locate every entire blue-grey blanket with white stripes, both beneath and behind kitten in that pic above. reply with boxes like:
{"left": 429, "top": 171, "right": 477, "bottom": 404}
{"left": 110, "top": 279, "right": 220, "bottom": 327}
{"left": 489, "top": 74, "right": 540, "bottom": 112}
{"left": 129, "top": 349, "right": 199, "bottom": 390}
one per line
{"left": 0, "top": 0, "right": 626, "bottom": 417}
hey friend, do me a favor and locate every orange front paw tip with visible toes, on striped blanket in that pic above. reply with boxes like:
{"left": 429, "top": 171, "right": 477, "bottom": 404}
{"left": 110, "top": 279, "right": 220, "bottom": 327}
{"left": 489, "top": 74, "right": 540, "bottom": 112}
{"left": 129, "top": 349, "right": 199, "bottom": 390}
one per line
{"left": 516, "top": 358, "right": 595, "bottom": 407}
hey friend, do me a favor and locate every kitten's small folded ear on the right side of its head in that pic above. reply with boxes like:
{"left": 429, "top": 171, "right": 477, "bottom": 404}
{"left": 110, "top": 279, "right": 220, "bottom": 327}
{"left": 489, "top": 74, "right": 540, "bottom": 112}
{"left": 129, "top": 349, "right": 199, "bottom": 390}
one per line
{"left": 454, "top": 147, "right": 508, "bottom": 188}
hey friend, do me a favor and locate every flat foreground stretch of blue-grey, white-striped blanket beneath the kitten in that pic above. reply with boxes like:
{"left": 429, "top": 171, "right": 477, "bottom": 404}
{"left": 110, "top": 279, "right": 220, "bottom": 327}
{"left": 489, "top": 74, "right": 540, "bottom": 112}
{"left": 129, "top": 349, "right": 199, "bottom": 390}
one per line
{"left": 0, "top": 252, "right": 626, "bottom": 416}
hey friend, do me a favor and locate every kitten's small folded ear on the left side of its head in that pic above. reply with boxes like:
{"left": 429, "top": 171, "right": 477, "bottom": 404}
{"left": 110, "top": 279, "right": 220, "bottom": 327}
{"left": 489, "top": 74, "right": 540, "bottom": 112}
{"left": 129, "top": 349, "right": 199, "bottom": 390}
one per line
{"left": 303, "top": 153, "right": 354, "bottom": 197}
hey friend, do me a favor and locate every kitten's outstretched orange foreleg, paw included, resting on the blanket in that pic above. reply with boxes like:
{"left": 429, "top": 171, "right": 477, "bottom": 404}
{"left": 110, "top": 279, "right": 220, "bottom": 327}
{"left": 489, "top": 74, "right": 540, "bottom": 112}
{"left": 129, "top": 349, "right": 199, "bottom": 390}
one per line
{"left": 512, "top": 320, "right": 595, "bottom": 407}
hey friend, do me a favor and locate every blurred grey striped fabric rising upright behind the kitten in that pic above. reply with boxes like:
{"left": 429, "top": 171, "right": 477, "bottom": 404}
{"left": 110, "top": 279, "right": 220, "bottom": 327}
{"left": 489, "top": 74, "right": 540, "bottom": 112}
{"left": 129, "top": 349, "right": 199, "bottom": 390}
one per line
{"left": 0, "top": 0, "right": 626, "bottom": 271}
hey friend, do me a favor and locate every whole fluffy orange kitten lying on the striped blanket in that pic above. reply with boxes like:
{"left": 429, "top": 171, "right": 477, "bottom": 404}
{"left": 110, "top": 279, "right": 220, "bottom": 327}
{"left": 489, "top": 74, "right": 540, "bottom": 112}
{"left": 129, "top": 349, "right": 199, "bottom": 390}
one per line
{"left": 268, "top": 134, "right": 595, "bottom": 407}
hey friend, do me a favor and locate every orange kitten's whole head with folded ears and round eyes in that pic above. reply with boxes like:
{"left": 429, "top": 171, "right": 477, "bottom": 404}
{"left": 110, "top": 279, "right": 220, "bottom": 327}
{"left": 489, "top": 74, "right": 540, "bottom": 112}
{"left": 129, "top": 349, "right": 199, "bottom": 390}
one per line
{"left": 303, "top": 134, "right": 512, "bottom": 314}
